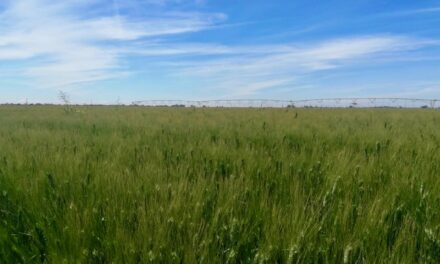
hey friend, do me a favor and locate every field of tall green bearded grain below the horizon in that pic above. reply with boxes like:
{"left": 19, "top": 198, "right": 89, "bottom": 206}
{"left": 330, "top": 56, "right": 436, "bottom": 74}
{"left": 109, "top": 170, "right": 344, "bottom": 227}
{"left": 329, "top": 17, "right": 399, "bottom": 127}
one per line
{"left": 0, "top": 106, "right": 440, "bottom": 263}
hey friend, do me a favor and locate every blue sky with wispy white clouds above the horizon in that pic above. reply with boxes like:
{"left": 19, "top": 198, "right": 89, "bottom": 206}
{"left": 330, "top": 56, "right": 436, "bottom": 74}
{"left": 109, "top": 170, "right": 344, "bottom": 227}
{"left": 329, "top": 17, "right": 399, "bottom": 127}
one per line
{"left": 0, "top": 0, "right": 440, "bottom": 103}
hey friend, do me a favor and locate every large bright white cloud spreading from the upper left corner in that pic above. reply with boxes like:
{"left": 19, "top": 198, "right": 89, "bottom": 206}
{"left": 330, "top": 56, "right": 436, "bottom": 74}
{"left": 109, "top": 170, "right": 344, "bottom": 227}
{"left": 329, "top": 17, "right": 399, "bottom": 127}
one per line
{"left": 0, "top": 0, "right": 225, "bottom": 87}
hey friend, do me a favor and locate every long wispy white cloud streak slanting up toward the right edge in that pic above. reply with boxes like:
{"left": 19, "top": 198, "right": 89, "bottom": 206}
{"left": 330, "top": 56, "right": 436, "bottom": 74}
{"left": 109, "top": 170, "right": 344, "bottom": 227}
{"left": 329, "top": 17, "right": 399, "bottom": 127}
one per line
{"left": 165, "top": 35, "right": 432, "bottom": 97}
